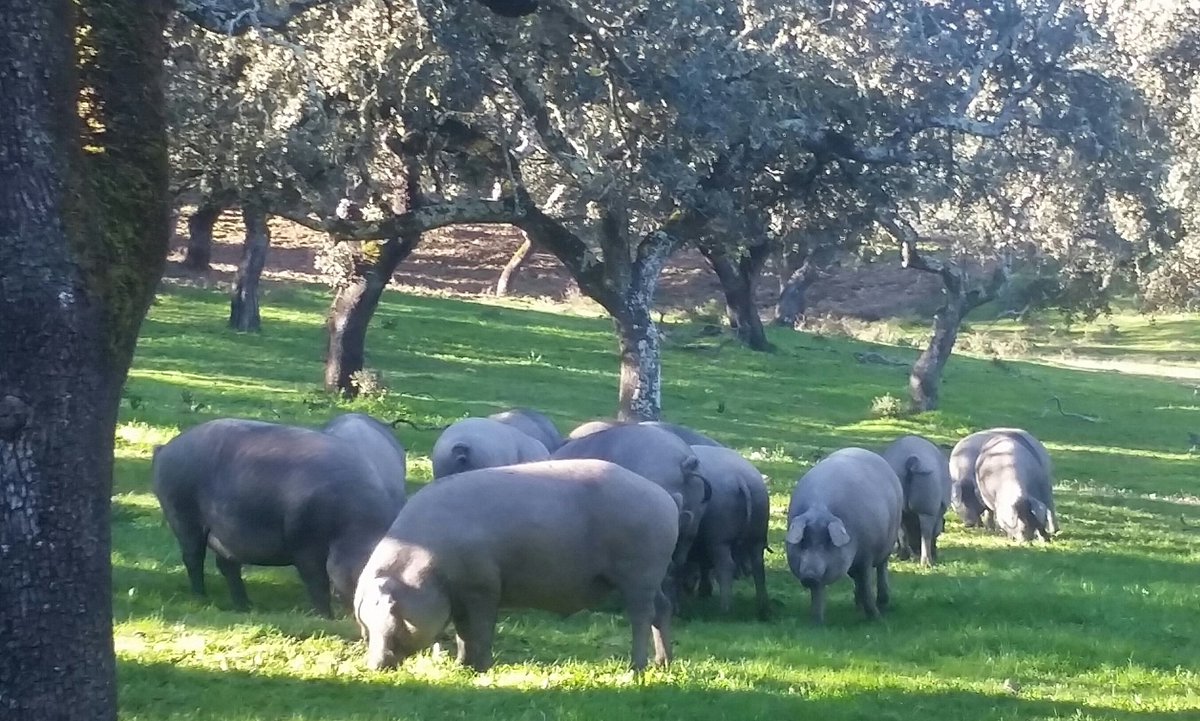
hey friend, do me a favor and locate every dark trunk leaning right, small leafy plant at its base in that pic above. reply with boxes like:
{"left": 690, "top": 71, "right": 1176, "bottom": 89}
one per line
{"left": 325, "top": 235, "right": 421, "bottom": 397}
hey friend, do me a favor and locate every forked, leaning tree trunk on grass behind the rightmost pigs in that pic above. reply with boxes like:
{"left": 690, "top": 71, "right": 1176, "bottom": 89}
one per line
{"left": 878, "top": 212, "right": 1008, "bottom": 411}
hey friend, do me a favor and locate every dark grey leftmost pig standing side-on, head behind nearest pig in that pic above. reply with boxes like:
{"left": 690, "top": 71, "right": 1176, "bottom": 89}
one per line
{"left": 152, "top": 419, "right": 400, "bottom": 617}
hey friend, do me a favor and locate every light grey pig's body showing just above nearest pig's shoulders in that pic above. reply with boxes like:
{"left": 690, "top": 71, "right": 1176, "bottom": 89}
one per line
{"left": 430, "top": 417, "right": 550, "bottom": 479}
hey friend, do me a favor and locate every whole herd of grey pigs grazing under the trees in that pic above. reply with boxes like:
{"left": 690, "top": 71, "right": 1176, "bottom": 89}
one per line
{"left": 152, "top": 409, "right": 1058, "bottom": 671}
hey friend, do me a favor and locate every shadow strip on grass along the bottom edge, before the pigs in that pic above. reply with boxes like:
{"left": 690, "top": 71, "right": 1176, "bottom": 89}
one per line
{"left": 119, "top": 660, "right": 1195, "bottom": 721}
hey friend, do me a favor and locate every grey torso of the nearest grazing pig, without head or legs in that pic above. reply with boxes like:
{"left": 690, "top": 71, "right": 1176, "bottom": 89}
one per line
{"left": 388, "top": 459, "right": 678, "bottom": 612}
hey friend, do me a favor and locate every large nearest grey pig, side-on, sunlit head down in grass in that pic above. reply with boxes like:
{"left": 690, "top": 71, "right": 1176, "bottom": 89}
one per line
{"left": 354, "top": 459, "right": 679, "bottom": 671}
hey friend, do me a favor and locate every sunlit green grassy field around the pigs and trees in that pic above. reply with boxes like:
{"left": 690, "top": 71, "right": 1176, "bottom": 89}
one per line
{"left": 113, "top": 287, "right": 1200, "bottom": 721}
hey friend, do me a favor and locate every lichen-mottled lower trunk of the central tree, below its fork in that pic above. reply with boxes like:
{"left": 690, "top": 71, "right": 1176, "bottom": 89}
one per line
{"left": 613, "top": 299, "right": 662, "bottom": 421}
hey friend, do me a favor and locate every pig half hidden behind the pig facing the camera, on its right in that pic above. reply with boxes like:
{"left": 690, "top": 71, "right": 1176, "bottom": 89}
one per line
{"left": 880, "top": 435, "right": 950, "bottom": 566}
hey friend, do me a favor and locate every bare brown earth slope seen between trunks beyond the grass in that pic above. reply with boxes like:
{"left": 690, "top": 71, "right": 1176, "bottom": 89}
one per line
{"left": 167, "top": 211, "right": 940, "bottom": 319}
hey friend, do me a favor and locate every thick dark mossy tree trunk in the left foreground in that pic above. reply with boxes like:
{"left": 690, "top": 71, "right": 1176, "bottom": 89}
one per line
{"left": 0, "top": 0, "right": 169, "bottom": 721}
